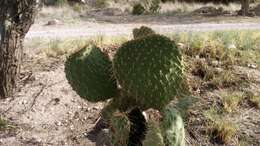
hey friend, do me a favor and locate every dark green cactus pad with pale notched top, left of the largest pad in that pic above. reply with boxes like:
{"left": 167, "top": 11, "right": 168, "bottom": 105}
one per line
{"left": 65, "top": 46, "right": 117, "bottom": 102}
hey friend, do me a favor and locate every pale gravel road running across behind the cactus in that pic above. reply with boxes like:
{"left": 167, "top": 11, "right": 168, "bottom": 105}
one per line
{"left": 26, "top": 22, "right": 260, "bottom": 39}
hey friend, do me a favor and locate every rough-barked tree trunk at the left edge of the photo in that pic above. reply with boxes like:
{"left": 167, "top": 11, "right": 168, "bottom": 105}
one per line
{"left": 0, "top": 0, "right": 38, "bottom": 99}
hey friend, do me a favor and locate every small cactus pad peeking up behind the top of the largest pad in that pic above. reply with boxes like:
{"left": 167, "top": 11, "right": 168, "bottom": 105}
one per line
{"left": 133, "top": 26, "right": 155, "bottom": 39}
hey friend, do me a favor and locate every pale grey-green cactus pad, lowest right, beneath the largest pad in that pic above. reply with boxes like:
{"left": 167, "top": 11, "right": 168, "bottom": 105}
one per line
{"left": 161, "top": 106, "right": 185, "bottom": 146}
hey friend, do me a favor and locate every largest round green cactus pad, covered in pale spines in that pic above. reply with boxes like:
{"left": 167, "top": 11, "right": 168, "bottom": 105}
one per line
{"left": 114, "top": 34, "right": 183, "bottom": 109}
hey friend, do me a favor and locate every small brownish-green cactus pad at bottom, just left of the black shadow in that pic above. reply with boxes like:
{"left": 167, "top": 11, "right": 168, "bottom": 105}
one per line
{"left": 109, "top": 112, "right": 131, "bottom": 146}
